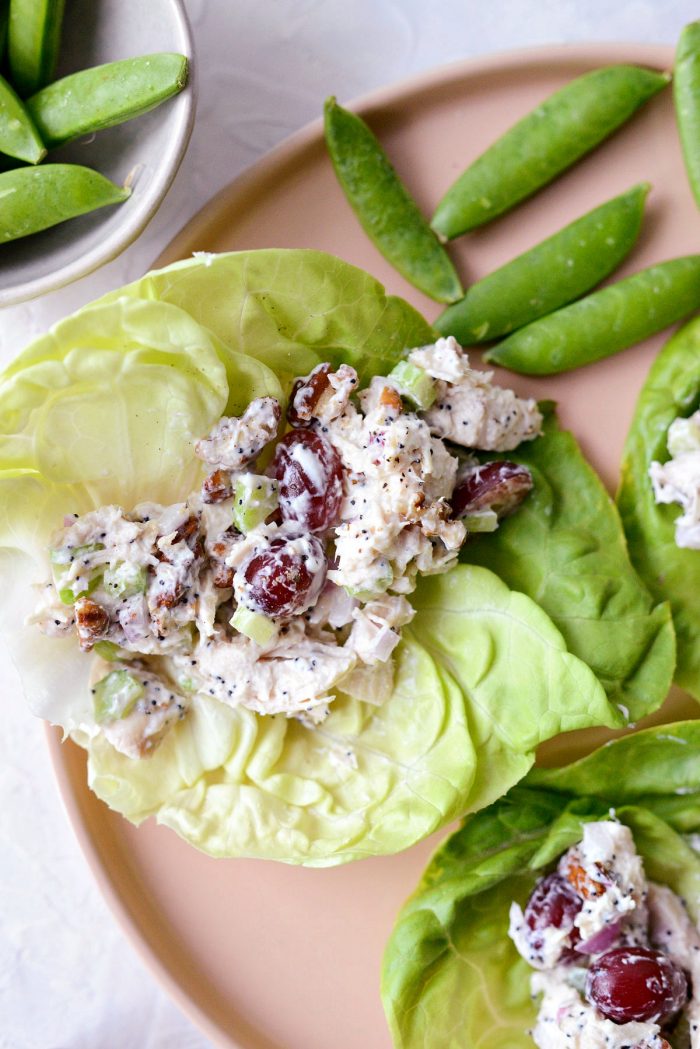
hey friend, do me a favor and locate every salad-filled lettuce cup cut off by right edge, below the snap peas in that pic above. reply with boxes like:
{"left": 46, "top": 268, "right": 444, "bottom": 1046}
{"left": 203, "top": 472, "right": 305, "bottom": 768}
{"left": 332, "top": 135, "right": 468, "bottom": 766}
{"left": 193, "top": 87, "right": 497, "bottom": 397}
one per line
{"left": 617, "top": 318, "right": 700, "bottom": 699}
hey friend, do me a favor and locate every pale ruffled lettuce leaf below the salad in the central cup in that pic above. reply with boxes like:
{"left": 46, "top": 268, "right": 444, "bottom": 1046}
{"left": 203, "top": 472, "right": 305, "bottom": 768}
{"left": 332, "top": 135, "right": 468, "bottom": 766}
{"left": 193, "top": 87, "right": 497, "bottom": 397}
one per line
{"left": 82, "top": 568, "right": 612, "bottom": 865}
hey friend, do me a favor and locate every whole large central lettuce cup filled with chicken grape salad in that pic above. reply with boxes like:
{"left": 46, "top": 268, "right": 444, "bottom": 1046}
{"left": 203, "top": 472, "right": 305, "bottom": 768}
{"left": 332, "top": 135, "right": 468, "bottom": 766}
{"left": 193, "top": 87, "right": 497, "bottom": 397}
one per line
{"left": 0, "top": 251, "right": 674, "bottom": 865}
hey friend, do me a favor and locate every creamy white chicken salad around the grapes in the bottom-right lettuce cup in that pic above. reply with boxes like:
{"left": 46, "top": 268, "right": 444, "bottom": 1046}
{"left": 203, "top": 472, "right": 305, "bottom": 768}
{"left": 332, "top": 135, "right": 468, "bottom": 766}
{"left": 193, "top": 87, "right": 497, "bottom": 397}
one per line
{"left": 509, "top": 819, "right": 700, "bottom": 1049}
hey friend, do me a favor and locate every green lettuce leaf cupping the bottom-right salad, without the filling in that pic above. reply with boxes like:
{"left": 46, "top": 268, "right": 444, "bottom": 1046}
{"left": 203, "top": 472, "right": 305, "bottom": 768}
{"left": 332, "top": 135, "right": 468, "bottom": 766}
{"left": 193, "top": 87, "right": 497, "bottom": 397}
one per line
{"left": 382, "top": 722, "right": 700, "bottom": 1049}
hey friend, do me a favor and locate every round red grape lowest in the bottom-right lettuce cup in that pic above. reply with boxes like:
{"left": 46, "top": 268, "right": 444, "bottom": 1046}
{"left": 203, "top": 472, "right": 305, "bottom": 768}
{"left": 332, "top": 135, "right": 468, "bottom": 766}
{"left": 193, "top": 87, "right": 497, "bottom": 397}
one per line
{"left": 586, "top": 947, "right": 687, "bottom": 1024}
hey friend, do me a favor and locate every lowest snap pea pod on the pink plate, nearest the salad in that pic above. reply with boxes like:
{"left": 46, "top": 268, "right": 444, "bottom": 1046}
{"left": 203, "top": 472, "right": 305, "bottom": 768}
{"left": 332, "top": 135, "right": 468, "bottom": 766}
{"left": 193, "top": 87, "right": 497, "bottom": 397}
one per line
{"left": 484, "top": 255, "right": 700, "bottom": 376}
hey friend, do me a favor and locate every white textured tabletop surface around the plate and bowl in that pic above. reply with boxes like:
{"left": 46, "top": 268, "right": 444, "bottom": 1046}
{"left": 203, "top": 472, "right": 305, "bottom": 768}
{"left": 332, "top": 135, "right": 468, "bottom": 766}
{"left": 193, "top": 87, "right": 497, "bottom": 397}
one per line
{"left": 0, "top": 0, "right": 698, "bottom": 1049}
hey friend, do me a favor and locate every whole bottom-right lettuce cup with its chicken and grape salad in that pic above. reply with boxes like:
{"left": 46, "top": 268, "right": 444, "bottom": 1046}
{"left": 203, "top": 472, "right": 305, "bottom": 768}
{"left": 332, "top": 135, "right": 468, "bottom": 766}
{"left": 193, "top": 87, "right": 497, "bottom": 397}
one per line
{"left": 382, "top": 722, "right": 700, "bottom": 1049}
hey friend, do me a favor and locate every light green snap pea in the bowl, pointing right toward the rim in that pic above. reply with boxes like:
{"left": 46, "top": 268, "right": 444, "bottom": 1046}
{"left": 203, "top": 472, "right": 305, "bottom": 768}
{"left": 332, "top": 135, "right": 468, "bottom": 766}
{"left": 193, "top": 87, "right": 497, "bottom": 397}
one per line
{"left": 26, "top": 52, "right": 188, "bottom": 149}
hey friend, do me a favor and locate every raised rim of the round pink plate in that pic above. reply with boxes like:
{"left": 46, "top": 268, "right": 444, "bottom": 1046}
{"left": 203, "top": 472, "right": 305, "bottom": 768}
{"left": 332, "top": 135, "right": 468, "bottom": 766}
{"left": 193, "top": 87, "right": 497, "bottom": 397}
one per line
{"left": 44, "top": 38, "right": 674, "bottom": 1049}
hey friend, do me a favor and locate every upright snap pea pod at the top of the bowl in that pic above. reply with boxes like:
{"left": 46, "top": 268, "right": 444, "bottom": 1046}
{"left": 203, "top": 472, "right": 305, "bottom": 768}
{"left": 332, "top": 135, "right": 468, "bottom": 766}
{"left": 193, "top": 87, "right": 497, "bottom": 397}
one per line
{"left": 7, "top": 0, "right": 65, "bottom": 97}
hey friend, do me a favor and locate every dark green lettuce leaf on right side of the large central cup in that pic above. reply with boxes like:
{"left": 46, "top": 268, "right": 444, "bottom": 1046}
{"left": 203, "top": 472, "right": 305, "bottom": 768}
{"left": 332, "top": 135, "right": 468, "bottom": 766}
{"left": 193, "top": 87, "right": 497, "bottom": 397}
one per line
{"left": 461, "top": 416, "right": 675, "bottom": 722}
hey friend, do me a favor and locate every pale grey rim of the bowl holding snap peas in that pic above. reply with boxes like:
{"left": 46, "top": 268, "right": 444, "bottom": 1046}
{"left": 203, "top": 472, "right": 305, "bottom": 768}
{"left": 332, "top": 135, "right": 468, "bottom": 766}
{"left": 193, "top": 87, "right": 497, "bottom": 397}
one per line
{"left": 0, "top": 0, "right": 196, "bottom": 307}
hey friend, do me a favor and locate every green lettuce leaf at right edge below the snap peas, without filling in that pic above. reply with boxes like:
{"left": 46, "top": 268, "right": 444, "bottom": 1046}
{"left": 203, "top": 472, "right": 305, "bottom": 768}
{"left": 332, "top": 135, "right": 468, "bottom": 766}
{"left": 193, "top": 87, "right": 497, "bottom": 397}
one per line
{"left": 617, "top": 318, "right": 700, "bottom": 700}
